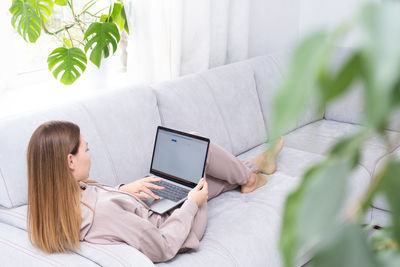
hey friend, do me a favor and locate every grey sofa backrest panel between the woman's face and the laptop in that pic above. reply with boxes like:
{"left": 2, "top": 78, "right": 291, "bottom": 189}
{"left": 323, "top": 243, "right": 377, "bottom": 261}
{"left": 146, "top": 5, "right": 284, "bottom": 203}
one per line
{"left": 81, "top": 86, "right": 161, "bottom": 185}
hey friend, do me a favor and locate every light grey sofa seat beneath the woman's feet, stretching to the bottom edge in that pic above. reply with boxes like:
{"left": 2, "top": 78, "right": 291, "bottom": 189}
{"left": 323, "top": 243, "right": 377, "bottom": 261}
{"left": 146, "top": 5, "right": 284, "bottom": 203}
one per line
{"left": 156, "top": 140, "right": 370, "bottom": 267}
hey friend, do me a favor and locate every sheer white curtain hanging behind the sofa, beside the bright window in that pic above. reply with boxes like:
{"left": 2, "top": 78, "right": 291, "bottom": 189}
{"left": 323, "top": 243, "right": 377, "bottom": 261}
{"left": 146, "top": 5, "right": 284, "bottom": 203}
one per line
{"left": 127, "top": 0, "right": 250, "bottom": 83}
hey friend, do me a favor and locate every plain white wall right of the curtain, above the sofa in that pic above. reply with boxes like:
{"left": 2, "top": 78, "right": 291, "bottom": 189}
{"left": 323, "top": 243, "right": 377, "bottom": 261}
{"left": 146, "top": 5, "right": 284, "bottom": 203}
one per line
{"left": 248, "top": 0, "right": 380, "bottom": 57}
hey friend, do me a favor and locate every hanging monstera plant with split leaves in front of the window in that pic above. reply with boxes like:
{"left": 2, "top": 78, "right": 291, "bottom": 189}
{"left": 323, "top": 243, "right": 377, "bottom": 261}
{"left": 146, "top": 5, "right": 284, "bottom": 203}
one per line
{"left": 10, "top": 0, "right": 129, "bottom": 85}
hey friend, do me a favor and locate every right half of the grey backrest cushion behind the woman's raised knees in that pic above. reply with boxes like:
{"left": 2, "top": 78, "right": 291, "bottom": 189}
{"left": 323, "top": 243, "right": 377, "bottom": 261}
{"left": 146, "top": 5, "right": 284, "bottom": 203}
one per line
{"left": 199, "top": 62, "right": 267, "bottom": 155}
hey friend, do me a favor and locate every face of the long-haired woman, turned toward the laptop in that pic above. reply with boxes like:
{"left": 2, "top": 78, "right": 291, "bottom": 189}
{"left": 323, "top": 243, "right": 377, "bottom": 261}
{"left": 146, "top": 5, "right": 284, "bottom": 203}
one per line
{"left": 68, "top": 135, "right": 90, "bottom": 181}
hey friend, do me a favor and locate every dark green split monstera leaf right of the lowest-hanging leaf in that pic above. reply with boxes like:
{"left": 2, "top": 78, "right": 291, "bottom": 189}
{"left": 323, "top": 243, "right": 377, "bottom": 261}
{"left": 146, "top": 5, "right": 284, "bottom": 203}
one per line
{"left": 84, "top": 22, "right": 120, "bottom": 67}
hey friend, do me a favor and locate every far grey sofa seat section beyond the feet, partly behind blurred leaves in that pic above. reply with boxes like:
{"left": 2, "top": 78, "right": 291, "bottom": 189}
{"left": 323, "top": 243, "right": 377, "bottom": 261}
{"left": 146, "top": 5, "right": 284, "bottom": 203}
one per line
{"left": 285, "top": 120, "right": 400, "bottom": 175}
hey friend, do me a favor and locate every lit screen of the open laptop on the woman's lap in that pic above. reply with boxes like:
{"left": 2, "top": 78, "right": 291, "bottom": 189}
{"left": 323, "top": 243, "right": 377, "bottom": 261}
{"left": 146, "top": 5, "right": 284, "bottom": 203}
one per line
{"left": 150, "top": 129, "right": 208, "bottom": 184}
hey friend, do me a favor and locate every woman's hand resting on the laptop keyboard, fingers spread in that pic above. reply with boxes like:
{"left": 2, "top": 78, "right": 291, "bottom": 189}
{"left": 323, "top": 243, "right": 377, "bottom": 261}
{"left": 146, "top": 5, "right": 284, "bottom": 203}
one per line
{"left": 119, "top": 176, "right": 164, "bottom": 199}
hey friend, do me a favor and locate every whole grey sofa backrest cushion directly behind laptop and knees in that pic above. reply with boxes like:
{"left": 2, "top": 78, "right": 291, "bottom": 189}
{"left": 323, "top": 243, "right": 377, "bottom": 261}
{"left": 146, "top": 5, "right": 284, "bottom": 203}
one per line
{"left": 153, "top": 62, "right": 267, "bottom": 155}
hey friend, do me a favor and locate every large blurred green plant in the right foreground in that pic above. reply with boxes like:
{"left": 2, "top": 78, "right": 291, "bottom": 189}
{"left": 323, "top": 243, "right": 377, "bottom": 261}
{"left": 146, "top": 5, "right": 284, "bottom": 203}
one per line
{"left": 270, "top": 1, "right": 400, "bottom": 267}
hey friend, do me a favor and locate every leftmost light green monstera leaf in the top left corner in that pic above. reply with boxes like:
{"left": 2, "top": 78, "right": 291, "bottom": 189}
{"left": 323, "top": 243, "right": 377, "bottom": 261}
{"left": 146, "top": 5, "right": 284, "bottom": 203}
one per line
{"left": 10, "top": 0, "right": 42, "bottom": 43}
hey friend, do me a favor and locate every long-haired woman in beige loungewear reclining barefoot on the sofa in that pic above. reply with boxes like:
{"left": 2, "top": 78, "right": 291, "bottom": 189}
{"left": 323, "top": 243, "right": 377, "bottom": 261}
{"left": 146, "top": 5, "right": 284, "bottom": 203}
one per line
{"left": 27, "top": 121, "right": 283, "bottom": 262}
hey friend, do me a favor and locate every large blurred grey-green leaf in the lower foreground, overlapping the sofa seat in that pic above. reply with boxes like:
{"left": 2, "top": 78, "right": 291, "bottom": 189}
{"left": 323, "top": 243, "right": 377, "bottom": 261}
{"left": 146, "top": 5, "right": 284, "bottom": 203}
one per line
{"left": 280, "top": 158, "right": 352, "bottom": 266}
